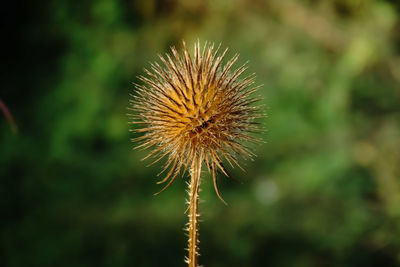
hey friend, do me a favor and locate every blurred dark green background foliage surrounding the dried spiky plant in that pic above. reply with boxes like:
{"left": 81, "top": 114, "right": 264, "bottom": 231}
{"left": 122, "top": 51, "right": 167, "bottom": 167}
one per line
{"left": 0, "top": 0, "right": 400, "bottom": 267}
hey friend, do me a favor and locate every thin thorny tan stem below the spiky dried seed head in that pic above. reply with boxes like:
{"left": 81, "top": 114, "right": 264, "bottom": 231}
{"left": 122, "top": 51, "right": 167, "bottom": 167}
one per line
{"left": 187, "top": 156, "right": 202, "bottom": 267}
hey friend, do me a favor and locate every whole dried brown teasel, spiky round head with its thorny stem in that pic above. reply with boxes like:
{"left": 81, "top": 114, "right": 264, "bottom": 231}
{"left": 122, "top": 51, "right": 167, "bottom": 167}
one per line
{"left": 129, "top": 42, "right": 260, "bottom": 266}
